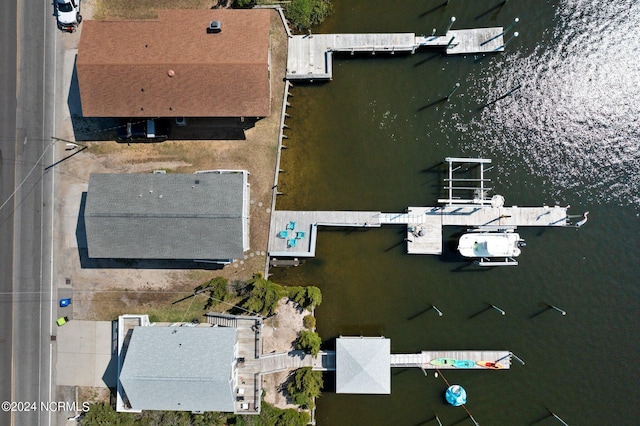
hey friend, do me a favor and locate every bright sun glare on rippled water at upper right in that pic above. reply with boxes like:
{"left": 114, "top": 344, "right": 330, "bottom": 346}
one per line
{"left": 451, "top": 0, "right": 640, "bottom": 206}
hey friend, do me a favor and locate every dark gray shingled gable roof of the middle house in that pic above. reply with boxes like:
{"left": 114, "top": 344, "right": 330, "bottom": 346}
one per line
{"left": 84, "top": 172, "right": 248, "bottom": 260}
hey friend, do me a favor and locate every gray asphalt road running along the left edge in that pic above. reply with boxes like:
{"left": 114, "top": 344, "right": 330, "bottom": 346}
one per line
{"left": 0, "top": 0, "right": 57, "bottom": 425}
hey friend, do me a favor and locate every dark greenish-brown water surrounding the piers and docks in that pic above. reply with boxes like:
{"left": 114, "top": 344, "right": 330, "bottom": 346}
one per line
{"left": 271, "top": 0, "right": 640, "bottom": 426}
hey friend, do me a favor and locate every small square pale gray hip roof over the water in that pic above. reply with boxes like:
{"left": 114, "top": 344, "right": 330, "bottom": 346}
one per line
{"left": 336, "top": 337, "right": 391, "bottom": 394}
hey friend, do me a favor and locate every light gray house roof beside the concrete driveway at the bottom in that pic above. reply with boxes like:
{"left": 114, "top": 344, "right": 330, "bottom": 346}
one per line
{"left": 120, "top": 327, "right": 236, "bottom": 412}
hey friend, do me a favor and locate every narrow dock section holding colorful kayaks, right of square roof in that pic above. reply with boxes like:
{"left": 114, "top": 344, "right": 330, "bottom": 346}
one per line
{"left": 389, "top": 350, "right": 511, "bottom": 370}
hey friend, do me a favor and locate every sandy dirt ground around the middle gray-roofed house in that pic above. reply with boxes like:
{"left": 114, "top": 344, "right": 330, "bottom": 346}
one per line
{"left": 53, "top": 0, "right": 308, "bottom": 406}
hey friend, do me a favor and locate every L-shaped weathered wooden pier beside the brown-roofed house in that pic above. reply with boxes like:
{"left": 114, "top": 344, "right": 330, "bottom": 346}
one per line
{"left": 286, "top": 27, "right": 505, "bottom": 80}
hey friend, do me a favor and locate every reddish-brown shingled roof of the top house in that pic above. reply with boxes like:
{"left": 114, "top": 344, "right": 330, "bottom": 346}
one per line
{"left": 76, "top": 9, "right": 270, "bottom": 117}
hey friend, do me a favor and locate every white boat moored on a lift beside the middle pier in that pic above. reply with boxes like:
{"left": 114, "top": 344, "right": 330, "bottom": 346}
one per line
{"left": 458, "top": 232, "right": 526, "bottom": 266}
